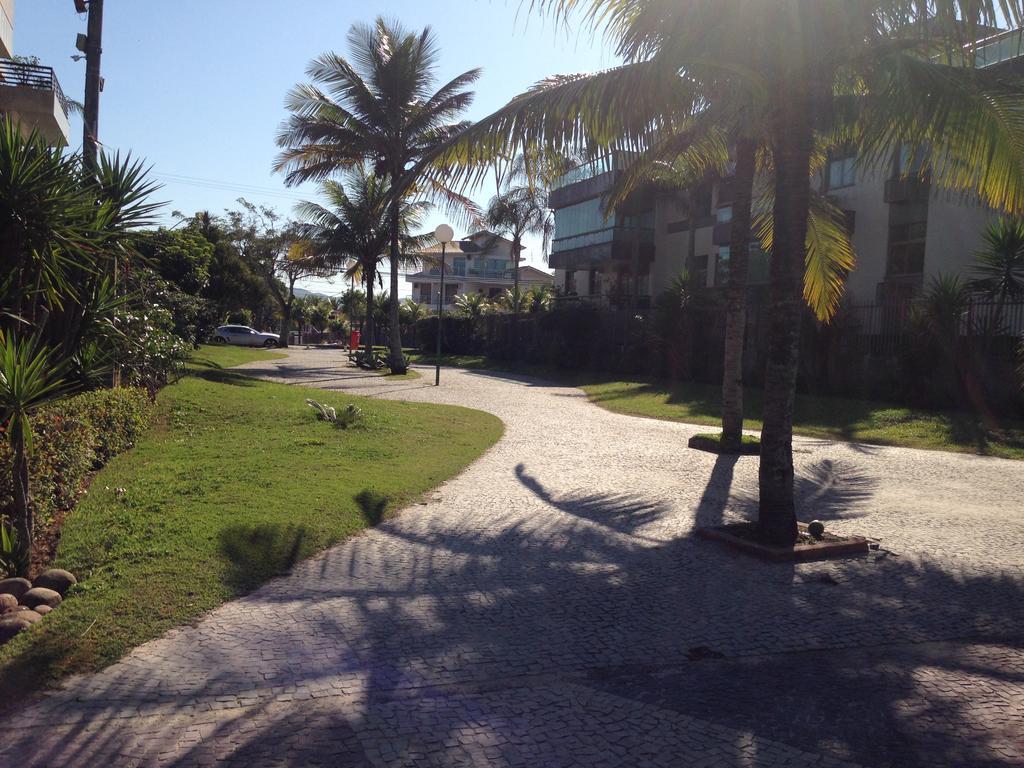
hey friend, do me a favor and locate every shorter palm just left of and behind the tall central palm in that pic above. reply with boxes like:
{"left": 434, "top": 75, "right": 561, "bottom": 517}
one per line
{"left": 296, "top": 164, "right": 427, "bottom": 359}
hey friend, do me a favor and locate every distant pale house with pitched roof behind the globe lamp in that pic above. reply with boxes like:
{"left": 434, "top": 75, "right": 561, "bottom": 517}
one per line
{"left": 406, "top": 230, "right": 554, "bottom": 308}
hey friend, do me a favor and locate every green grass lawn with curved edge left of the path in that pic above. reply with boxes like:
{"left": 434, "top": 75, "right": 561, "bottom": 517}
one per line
{"left": 0, "top": 347, "right": 503, "bottom": 702}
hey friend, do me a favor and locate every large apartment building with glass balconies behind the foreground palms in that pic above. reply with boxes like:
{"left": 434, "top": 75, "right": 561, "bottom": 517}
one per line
{"left": 550, "top": 30, "right": 1024, "bottom": 306}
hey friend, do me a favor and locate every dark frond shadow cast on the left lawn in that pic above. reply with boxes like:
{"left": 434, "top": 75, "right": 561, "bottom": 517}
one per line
{"left": 219, "top": 523, "right": 306, "bottom": 593}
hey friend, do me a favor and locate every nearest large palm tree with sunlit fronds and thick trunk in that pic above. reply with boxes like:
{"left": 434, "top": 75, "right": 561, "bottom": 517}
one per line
{"left": 454, "top": 0, "right": 1024, "bottom": 544}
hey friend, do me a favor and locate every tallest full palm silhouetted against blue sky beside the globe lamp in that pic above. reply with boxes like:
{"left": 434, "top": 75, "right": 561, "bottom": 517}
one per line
{"left": 275, "top": 18, "right": 480, "bottom": 374}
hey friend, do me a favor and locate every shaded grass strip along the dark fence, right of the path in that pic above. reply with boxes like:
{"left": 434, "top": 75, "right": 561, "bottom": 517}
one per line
{"left": 403, "top": 355, "right": 1024, "bottom": 460}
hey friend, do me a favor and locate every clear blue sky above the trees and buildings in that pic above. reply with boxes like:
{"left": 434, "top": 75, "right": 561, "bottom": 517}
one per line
{"left": 14, "top": 0, "right": 614, "bottom": 293}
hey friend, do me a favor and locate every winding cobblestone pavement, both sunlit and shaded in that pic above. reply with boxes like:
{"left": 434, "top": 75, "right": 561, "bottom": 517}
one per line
{"left": 0, "top": 350, "right": 1024, "bottom": 768}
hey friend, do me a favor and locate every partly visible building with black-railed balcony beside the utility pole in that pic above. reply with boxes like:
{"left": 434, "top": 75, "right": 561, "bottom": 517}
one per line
{"left": 0, "top": 0, "right": 71, "bottom": 144}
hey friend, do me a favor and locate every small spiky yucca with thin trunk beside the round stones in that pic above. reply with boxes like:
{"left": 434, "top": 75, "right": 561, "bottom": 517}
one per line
{"left": 0, "top": 333, "right": 68, "bottom": 575}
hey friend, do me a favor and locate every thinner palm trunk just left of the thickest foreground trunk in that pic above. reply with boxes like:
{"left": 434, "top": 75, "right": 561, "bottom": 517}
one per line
{"left": 721, "top": 138, "right": 757, "bottom": 453}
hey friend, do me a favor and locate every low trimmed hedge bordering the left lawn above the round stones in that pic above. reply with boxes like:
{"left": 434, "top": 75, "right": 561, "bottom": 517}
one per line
{"left": 0, "top": 387, "right": 153, "bottom": 523}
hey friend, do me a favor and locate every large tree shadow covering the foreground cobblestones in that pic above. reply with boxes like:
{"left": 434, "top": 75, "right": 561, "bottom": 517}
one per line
{"left": 9, "top": 461, "right": 1024, "bottom": 768}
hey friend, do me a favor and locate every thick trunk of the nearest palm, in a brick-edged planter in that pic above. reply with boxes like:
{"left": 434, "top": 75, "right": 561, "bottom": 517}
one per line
{"left": 758, "top": 91, "right": 814, "bottom": 546}
